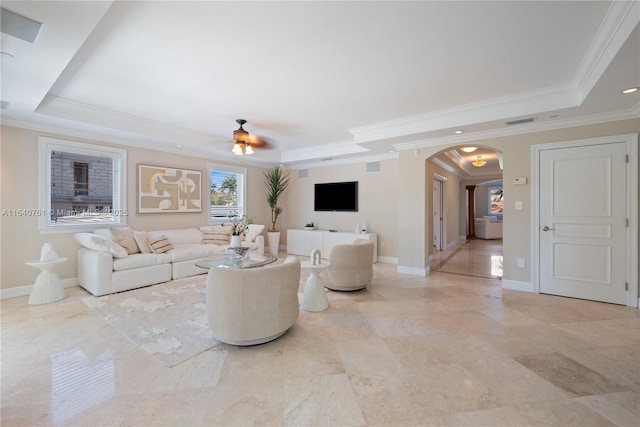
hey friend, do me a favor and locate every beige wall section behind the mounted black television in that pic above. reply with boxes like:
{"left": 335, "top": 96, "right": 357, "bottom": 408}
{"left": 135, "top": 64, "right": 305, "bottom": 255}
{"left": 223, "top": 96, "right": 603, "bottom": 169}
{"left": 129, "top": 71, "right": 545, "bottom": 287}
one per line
{"left": 280, "top": 159, "right": 399, "bottom": 258}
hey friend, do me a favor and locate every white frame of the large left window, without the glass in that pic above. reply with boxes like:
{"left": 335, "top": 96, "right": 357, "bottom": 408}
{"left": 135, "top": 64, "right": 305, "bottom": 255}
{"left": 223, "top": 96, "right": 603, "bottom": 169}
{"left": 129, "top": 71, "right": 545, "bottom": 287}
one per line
{"left": 38, "top": 137, "right": 129, "bottom": 234}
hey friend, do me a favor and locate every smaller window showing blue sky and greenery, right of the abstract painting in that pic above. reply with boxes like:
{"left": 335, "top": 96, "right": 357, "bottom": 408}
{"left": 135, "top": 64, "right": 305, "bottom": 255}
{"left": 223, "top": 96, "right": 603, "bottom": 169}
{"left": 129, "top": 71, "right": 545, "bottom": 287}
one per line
{"left": 209, "top": 164, "right": 247, "bottom": 224}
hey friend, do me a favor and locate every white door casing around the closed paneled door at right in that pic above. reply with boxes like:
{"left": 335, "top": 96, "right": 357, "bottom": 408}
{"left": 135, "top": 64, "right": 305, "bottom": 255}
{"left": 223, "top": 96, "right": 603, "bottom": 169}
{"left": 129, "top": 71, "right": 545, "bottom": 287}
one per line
{"left": 531, "top": 133, "right": 639, "bottom": 307}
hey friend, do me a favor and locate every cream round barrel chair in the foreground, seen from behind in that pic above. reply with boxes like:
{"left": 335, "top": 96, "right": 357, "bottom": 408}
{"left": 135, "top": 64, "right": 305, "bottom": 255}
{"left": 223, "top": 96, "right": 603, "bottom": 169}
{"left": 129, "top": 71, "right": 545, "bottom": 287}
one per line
{"left": 206, "top": 257, "right": 300, "bottom": 346}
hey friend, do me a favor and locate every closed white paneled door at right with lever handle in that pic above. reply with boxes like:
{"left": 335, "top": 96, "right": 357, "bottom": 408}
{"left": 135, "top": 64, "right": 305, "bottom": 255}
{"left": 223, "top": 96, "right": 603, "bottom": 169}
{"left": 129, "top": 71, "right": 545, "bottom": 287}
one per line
{"left": 539, "top": 142, "right": 627, "bottom": 304}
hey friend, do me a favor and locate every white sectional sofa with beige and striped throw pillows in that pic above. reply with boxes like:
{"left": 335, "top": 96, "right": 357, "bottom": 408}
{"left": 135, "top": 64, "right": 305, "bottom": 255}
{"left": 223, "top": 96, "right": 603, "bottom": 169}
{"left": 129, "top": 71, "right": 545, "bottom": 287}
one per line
{"left": 76, "top": 224, "right": 264, "bottom": 296}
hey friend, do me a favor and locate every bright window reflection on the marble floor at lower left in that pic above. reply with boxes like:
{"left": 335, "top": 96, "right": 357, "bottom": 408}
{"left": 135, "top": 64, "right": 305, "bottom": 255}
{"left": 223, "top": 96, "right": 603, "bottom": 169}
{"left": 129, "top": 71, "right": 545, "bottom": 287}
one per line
{"left": 51, "top": 348, "right": 115, "bottom": 424}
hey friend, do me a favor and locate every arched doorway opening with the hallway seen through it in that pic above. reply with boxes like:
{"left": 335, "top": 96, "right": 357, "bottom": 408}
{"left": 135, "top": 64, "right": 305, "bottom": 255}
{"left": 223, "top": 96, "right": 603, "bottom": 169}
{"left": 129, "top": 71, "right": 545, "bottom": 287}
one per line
{"left": 425, "top": 145, "right": 504, "bottom": 277}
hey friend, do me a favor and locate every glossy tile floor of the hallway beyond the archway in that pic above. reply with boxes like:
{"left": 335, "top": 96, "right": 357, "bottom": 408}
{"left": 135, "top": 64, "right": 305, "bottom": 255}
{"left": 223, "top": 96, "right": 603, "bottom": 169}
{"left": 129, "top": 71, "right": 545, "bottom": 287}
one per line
{"left": 431, "top": 239, "right": 502, "bottom": 279}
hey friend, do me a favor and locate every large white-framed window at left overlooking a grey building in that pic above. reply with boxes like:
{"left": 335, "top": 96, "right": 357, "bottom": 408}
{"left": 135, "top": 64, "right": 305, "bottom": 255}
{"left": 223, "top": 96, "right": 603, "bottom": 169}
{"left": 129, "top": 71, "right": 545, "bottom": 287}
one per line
{"left": 39, "top": 137, "right": 128, "bottom": 233}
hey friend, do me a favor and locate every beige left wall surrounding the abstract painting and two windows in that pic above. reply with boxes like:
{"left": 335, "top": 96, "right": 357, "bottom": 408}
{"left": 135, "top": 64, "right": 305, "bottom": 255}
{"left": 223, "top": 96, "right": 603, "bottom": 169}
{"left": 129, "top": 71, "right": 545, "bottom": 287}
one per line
{"left": 0, "top": 126, "right": 270, "bottom": 289}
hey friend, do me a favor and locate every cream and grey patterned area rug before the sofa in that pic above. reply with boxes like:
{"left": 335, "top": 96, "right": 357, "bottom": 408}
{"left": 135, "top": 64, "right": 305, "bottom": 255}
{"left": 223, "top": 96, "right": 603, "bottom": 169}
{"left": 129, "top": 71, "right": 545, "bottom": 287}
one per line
{"left": 83, "top": 275, "right": 220, "bottom": 367}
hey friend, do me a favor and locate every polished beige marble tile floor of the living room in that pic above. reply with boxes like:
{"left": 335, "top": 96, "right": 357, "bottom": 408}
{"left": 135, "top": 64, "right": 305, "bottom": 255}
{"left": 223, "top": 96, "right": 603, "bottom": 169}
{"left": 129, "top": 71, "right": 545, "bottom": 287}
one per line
{"left": 0, "top": 256, "right": 640, "bottom": 427}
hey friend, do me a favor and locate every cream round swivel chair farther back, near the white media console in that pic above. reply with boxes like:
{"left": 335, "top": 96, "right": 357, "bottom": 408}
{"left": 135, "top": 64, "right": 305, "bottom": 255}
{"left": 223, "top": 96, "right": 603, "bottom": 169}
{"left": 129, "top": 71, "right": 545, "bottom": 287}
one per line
{"left": 324, "top": 239, "right": 375, "bottom": 291}
